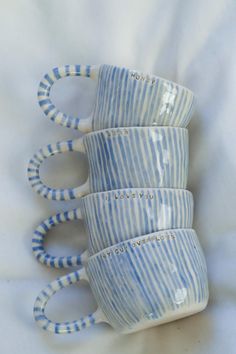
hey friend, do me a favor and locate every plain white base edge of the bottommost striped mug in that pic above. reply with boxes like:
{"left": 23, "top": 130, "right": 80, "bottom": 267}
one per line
{"left": 122, "top": 300, "right": 208, "bottom": 334}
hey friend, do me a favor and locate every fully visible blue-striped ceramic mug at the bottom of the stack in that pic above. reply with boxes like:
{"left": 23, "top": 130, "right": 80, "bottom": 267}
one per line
{"left": 34, "top": 229, "right": 208, "bottom": 334}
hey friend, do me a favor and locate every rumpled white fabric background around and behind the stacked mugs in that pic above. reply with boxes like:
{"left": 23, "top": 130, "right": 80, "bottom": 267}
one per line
{"left": 0, "top": 0, "right": 236, "bottom": 354}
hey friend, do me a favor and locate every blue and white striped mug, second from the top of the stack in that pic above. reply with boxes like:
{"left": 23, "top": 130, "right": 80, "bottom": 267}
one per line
{"left": 28, "top": 127, "right": 188, "bottom": 200}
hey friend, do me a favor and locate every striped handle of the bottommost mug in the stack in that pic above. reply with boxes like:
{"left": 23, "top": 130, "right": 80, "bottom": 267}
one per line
{"left": 33, "top": 268, "right": 107, "bottom": 334}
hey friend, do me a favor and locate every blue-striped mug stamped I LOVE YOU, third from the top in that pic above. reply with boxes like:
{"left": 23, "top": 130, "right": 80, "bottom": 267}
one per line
{"left": 32, "top": 188, "right": 193, "bottom": 268}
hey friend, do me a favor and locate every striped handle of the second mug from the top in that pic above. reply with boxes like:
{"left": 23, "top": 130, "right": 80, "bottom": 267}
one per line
{"left": 27, "top": 137, "right": 89, "bottom": 200}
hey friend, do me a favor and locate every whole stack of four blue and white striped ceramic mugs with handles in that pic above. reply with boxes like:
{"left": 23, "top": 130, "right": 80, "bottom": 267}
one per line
{"left": 28, "top": 65, "right": 208, "bottom": 333}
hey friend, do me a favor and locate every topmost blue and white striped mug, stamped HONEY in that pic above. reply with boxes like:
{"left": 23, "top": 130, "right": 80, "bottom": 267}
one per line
{"left": 38, "top": 65, "right": 194, "bottom": 132}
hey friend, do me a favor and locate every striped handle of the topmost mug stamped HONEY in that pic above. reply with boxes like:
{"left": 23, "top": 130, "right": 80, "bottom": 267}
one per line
{"left": 38, "top": 65, "right": 99, "bottom": 133}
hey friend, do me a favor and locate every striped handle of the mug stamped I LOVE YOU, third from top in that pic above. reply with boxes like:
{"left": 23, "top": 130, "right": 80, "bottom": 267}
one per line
{"left": 32, "top": 208, "right": 87, "bottom": 268}
